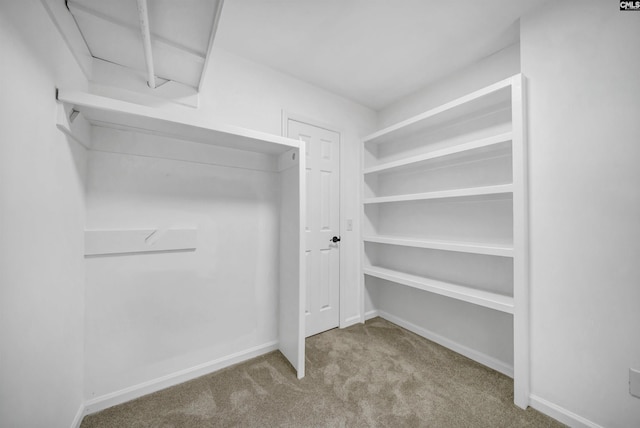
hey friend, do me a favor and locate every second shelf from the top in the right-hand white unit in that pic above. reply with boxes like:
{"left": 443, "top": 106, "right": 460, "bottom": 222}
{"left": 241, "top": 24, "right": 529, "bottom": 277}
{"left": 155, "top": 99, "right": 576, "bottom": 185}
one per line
{"left": 363, "top": 132, "right": 512, "bottom": 174}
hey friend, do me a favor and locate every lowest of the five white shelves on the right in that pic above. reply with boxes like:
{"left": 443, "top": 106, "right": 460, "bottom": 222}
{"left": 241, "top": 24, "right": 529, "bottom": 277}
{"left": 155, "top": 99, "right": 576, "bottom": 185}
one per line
{"left": 363, "top": 266, "right": 513, "bottom": 314}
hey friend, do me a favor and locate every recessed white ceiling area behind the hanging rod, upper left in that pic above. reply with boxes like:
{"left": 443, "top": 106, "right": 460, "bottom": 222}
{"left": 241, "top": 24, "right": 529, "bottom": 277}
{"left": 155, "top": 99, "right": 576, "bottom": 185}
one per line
{"left": 67, "top": 0, "right": 219, "bottom": 88}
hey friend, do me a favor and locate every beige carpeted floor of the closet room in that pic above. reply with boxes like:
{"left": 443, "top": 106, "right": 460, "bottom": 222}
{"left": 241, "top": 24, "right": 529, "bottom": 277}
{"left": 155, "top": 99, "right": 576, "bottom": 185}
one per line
{"left": 81, "top": 318, "right": 564, "bottom": 428}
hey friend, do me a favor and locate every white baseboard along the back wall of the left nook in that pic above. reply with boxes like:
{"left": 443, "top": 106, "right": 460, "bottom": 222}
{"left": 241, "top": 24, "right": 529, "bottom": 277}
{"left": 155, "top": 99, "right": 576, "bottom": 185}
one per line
{"left": 83, "top": 341, "right": 278, "bottom": 416}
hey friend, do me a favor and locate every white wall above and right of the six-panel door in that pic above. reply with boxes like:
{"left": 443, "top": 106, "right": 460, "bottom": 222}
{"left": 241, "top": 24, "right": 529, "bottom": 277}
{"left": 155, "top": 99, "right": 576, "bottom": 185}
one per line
{"left": 91, "top": 48, "right": 377, "bottom": 324}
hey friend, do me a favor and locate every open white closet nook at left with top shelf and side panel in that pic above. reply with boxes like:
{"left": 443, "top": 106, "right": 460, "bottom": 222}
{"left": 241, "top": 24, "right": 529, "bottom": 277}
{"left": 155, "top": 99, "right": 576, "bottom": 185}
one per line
{"left": 57, "top": 90, "right": 306, "bottom": 404}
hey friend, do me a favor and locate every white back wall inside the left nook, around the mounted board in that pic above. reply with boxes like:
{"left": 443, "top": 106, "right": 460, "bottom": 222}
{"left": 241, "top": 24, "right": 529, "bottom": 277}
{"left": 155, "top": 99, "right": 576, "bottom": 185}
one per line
{"left": 85, "top": 127, "right": 280, "bottom": 399}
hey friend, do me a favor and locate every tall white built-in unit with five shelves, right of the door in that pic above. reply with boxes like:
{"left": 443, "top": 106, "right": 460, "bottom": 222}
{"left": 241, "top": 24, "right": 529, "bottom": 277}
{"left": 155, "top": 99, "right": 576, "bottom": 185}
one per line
{"left": 362, "top": 75, "right": 529, "bottom": 408}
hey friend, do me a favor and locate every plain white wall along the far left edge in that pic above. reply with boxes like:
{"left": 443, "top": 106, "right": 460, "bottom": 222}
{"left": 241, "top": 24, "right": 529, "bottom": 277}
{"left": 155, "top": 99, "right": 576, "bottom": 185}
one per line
{"left": 0, "top": 1, "right": 86, "bottom": 427}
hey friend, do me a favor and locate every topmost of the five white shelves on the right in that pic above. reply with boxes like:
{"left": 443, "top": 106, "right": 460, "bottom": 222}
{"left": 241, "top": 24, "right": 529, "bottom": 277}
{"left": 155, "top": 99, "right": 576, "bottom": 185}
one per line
{"left": 364, "top": 78, "right": 513, "bottom": 144}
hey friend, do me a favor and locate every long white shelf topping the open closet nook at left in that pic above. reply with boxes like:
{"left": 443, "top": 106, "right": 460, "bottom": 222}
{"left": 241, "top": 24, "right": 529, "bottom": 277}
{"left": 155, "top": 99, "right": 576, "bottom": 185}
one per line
{"left": 58, "top": 91, "right": 300, "bottom": 154}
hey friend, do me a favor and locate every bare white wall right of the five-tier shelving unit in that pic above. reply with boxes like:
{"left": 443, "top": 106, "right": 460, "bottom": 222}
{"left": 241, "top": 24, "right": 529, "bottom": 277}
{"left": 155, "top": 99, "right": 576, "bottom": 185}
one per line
{"left": 521, "top": 0, "right": 640, "bottom": 427}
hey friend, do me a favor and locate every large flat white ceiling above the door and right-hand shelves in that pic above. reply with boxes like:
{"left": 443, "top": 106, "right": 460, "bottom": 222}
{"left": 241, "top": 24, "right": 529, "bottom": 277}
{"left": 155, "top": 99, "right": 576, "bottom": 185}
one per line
{"left": 215, "top": 0, "right": 545, "bottom": 110}
